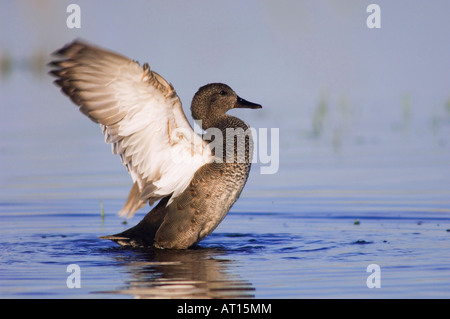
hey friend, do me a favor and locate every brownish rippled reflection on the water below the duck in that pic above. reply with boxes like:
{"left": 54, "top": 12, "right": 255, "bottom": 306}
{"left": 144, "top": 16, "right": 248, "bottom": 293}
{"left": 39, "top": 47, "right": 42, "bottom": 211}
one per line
{"left": 104, "top": 248, "right": 255, "bottom": 299}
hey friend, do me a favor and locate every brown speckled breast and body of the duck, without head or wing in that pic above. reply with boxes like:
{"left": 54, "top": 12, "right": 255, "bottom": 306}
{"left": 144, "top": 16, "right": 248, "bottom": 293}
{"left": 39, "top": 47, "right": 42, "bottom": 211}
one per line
{"left": 103, "top": 105, "right": 252, "bottom": 249}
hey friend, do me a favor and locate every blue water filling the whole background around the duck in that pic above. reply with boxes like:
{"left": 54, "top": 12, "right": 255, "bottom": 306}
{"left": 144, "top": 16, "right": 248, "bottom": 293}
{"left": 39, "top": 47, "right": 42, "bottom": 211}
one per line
{"left": 0, "top": 0, "right": 450, "bottom": 298}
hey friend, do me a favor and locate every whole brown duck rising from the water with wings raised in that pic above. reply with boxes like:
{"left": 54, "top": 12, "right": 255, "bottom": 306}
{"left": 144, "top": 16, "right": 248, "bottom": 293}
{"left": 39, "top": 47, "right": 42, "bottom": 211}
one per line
{"left": 49, "top": 39, "right": 261, "bottom": 249}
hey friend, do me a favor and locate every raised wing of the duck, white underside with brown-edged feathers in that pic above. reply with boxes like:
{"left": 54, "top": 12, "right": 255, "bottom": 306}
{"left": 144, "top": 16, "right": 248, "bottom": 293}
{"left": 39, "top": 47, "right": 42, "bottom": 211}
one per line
{"left": 50, "top": 40, "right": 213, "bottom": 217}
